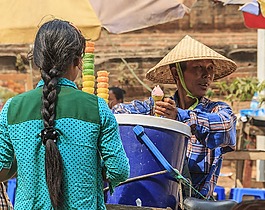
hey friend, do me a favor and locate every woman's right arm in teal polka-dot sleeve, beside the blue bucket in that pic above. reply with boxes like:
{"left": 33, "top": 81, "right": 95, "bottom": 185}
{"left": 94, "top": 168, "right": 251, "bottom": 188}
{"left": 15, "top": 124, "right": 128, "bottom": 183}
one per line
{"left": 98, "top": 98, "right": 130, "bottom": 193}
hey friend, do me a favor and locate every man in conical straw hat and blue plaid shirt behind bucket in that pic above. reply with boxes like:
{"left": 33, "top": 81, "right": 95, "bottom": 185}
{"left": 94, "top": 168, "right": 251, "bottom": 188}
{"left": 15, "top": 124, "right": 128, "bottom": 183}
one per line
{"left": 113, "top": 36, "right": 237, "bottom": 198}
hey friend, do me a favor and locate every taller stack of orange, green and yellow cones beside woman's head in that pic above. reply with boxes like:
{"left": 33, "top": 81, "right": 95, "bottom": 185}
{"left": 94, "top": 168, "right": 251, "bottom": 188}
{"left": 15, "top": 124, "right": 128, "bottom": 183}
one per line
{"left": 82, "top": 41, "right": 95, "bottom": 94}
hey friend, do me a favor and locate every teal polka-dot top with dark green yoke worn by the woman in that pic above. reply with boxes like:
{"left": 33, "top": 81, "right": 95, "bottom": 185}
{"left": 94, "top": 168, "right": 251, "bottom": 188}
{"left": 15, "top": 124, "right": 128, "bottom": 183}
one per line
{"left": 0, "top": 79, "right": 129, "bottom": 210}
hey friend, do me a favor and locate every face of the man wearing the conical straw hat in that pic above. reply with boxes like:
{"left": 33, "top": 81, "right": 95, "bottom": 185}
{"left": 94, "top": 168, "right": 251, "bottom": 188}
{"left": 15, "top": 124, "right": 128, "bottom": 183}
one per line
{"left": 183, "top": 60, "right": 214, "bottom": 98}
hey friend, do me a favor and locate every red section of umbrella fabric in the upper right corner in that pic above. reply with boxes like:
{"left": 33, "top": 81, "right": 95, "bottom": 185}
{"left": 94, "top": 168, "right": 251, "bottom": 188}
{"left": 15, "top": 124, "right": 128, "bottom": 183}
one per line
{"left": 243, "top": 12, "right": 265, "bottom": 29}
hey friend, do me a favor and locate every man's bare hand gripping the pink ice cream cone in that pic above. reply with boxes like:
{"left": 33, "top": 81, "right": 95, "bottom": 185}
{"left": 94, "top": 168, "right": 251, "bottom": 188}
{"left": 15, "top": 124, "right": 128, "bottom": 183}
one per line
{"left": 155, "top": 98, "right": 178, "bottom": 120}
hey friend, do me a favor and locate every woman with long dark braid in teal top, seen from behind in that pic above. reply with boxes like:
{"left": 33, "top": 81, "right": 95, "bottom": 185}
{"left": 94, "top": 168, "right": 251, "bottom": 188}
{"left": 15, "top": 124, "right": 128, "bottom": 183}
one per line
{"left": 0, "top": 19, "right": 129, "bottom": 210}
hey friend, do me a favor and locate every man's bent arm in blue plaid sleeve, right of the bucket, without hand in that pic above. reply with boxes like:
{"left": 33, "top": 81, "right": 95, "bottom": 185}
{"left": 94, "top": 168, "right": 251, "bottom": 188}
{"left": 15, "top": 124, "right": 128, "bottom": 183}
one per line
{"left": 177, "top": 102, "right": 236, "bottom": 153}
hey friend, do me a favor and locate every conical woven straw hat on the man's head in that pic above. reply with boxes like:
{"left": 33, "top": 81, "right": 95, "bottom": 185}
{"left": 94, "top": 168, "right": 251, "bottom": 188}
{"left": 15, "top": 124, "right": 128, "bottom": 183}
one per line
{"left": 146, "top": 35, "right": 237, "bottom": 84}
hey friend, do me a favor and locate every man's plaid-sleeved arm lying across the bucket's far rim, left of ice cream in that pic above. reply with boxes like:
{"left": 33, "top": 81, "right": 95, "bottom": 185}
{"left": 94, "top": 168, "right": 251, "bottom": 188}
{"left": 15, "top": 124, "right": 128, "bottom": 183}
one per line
{"left": 112, "top": 97, "right": 154, "bottom": 115}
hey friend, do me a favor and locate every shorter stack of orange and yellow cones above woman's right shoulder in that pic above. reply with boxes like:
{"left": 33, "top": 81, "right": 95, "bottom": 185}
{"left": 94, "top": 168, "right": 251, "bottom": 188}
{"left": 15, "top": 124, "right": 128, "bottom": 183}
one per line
{"left": 97, "top": 71, "right": 109, "bottom": 103}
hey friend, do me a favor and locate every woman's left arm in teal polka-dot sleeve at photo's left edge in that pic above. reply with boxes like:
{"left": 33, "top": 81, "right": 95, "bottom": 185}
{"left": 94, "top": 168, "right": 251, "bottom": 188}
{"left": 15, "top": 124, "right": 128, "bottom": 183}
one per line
{"left": 0, "top": 99, "right": 17, "bottom": 182}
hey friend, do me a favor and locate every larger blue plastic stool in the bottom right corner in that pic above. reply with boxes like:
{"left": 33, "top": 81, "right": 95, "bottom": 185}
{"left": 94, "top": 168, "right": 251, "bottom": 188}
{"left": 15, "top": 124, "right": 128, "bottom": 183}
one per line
{"left": 229, "top": 188, "right": 265, "bottom": 203}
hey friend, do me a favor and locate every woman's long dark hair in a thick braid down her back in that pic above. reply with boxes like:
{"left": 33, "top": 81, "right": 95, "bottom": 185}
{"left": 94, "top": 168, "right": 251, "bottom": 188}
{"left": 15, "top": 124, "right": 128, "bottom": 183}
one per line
{"left": 33, "top": 19, "right": 85, "bottom": 209}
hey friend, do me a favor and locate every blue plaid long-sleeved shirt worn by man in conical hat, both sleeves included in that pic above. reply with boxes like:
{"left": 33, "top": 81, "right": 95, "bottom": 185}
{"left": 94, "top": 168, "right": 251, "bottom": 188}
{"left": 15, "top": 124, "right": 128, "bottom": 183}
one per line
{"left": 112, "top": 92, "right": 236, "bottom": 196}
